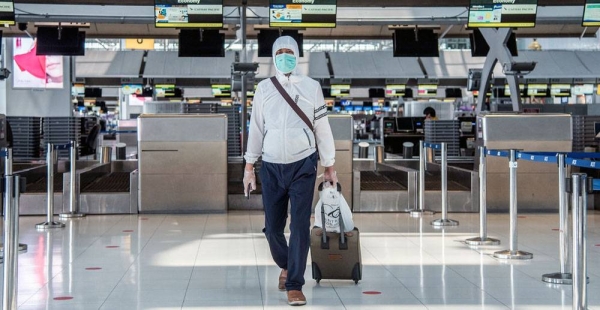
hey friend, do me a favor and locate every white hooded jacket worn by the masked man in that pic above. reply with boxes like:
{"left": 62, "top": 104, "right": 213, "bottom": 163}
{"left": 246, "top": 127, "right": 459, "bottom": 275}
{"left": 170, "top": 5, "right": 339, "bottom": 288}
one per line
{"left": 244, "top": 36, "right": 335, "bottom": 167}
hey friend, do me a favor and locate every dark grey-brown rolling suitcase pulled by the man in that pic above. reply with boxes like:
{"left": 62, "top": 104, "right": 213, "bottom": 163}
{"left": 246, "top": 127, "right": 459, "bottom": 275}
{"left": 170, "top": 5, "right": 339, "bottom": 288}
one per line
{"left": 310, "top": 183, "right": 362, "bottom": 283}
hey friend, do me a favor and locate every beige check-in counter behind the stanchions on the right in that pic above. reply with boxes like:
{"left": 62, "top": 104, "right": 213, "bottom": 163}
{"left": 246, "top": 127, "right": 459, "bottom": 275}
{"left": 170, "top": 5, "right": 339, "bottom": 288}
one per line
{"left": 475, "top": 113, "right": 573, "bottom": 211}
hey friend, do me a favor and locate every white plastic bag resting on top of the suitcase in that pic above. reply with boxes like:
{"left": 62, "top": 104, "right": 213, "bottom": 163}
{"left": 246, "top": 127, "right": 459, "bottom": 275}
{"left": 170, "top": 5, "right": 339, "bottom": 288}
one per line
{"left": 315, "top": 182, "right": 354, "bottom": 233}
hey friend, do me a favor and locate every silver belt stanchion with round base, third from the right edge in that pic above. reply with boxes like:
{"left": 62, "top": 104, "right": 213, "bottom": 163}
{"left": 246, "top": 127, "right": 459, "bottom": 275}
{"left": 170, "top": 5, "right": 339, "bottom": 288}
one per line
{"left": 494, "top": 150, "right": 533, "bottom": 259}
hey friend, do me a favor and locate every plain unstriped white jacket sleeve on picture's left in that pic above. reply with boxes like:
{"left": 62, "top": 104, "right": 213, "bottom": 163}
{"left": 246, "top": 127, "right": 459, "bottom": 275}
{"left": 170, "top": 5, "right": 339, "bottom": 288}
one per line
{"left": 242, "top": 82, "right": 265, "bottom": 164}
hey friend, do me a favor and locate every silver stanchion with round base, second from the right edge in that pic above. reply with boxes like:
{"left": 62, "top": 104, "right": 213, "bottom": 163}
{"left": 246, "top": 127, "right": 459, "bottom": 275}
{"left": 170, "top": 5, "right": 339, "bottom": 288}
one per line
{"left": 542, "top": 153, "right": 573, "bottom": 284}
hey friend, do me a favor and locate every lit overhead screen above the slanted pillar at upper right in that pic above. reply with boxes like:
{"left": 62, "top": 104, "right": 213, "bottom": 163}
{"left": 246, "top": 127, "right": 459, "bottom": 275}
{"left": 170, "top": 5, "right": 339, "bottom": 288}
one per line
{"left": 467, "top": 0, "right": 537, "bottom": 28}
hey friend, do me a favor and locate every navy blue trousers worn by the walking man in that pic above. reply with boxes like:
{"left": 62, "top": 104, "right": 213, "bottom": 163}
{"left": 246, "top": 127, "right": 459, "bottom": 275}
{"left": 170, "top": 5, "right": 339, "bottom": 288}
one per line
{"left": 260, "top": 152, "right": 317, "bottom": 291}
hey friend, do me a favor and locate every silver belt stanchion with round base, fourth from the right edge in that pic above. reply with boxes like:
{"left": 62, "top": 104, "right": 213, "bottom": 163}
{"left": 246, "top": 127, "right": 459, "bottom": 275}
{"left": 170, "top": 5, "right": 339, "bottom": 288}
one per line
{"left": 465, "top": 146, "right": 500, "bottom": 245}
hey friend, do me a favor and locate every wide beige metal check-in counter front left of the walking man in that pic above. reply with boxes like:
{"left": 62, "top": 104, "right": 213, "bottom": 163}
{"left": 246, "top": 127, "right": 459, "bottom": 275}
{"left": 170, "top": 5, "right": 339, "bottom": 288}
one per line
{"left": 138, "top": 114, "right": 227, "bottom": 213}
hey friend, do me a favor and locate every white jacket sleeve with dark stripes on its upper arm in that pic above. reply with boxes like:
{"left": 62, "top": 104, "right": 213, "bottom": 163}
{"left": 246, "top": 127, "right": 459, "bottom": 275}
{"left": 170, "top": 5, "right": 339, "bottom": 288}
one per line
{"left": 314, "top": 83, "right": 335, "bottom": 167}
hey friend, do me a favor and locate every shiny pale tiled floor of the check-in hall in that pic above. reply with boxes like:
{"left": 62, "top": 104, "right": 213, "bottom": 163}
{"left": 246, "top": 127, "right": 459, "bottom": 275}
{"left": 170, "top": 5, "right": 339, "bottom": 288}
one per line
{"left": 1, "top": 211, "right": 600, "bottom": 310}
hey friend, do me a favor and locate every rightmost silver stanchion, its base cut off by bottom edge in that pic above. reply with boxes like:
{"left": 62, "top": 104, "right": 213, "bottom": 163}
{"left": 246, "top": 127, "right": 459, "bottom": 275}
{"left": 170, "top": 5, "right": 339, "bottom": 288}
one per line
{"left": 571, "top": 173, "right": 591, "bottom": 310}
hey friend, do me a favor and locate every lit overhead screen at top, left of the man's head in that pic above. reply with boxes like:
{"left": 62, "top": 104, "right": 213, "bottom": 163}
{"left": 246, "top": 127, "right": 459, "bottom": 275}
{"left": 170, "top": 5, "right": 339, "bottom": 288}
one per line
{"left": 154, "top": 0, "right": 223, "bottom": 28}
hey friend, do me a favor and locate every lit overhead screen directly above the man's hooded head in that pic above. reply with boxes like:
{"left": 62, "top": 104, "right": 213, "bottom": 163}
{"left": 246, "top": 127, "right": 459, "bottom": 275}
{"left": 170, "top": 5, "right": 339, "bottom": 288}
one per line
{"left": 269, "top": 0, "right": 337, "bottom": 28}
